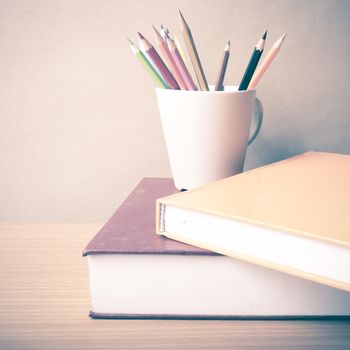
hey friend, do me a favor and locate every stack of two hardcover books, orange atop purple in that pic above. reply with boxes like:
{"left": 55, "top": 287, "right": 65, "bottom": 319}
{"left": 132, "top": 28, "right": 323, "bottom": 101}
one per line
{"left": 83, "top": 152, "right": 350, "bottom": 319}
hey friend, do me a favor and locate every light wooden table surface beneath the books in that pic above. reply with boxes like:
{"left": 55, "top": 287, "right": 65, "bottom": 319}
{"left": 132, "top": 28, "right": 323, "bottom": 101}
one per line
{"left": 0, "top": 223, "right": 350, "bottom": 350}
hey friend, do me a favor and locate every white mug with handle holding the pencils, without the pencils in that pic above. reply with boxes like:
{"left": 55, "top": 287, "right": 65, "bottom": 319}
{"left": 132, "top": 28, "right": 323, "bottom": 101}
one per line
{"left": 156, "top": 86, "right": 263, "bottom": 190}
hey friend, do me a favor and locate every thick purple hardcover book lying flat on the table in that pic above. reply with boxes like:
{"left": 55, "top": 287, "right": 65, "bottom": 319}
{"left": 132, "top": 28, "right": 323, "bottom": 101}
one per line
{"left": 83, "top": 178, "right": 350, "bottom": 319}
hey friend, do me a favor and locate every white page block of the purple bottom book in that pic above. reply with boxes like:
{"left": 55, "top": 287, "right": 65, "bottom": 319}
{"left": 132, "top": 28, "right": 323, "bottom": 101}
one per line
{"left": 88, "top": 254, "right": 350, "bottom": 318}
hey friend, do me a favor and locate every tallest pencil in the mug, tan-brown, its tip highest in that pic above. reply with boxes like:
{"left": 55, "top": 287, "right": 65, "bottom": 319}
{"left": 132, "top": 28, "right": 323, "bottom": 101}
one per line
{"left": 179, "top": 11, "right": 209, "bottom": 91}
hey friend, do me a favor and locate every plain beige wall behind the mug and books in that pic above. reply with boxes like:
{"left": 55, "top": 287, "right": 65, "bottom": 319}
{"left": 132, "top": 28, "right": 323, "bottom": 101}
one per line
{"left": 0, "top": 0, "right": 350, "bottom": 221}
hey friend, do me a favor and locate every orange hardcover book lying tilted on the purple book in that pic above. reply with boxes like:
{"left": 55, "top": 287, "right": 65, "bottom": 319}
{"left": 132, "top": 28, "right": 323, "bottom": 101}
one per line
{"left": 156, "top": 152, "right": 350, "bottom": 291}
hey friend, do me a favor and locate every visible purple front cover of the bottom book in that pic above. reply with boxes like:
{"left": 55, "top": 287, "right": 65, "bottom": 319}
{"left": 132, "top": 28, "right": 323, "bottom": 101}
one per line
{"left": 83, "top": 178, "right": 215, "bottom": 256}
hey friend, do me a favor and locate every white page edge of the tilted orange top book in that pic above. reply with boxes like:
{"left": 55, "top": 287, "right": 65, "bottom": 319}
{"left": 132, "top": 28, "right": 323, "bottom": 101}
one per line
{"left": 158, "top": 202, "right": 350, "bottom": 291}
